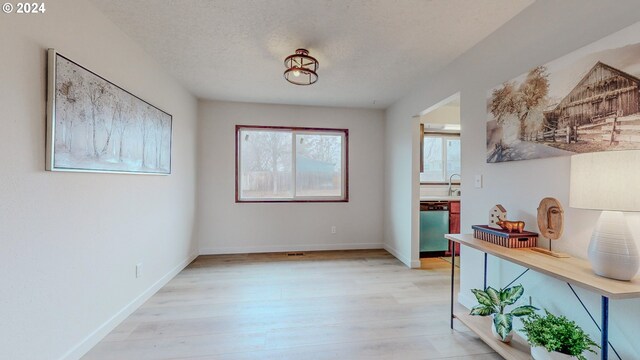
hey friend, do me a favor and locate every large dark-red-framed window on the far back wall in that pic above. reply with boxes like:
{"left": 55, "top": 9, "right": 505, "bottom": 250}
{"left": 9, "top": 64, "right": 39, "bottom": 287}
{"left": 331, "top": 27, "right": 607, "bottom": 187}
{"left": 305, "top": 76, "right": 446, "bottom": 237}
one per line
{"left": 236, "top": 125, "right": 349, "bottom": 202}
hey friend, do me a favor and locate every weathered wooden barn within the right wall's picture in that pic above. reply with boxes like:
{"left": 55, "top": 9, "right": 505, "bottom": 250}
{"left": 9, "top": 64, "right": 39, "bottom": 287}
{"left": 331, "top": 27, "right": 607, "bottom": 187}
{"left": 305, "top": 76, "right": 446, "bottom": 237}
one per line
{"left": 544, "top": 61, "right": 640, "bottom": 129}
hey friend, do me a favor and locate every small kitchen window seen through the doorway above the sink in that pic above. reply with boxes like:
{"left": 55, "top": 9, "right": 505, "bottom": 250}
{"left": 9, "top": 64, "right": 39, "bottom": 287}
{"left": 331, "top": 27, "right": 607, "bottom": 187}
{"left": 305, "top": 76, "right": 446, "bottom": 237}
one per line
{"left": 420, "top": 133, "right": 460, "bottom": 183}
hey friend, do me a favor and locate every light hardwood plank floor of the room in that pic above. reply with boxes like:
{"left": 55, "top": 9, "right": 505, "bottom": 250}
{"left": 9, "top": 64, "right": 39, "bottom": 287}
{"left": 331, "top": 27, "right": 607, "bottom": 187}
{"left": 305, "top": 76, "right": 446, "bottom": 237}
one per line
{"left": 83, "top": 250, "right": 501, "bottom": 360}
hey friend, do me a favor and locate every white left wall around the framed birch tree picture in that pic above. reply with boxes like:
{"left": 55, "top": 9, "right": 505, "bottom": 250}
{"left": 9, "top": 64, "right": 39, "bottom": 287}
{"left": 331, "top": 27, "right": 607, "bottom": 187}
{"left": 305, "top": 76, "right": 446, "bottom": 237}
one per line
{"left": 0, "top": 0, "right": 197, "bottom": 360}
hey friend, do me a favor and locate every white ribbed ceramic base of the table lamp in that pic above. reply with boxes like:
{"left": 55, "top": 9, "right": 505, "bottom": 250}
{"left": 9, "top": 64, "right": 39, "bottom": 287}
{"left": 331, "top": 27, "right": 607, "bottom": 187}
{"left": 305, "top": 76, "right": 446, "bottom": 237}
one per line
{"left": 589, "top": 211, "right": 640, "bottom": 281}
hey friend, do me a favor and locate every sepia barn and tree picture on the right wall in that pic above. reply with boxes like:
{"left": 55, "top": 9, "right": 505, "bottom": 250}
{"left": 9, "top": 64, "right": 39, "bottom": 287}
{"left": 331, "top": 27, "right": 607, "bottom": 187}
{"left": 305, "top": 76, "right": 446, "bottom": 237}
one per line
{"left": 487, "top": 23, "right": 640, "bottom": 163}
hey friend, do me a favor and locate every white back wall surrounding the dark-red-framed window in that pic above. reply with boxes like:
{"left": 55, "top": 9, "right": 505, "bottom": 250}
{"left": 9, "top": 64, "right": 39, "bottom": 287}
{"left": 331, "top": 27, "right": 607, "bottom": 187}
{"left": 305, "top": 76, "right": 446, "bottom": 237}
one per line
{"left": 198, "top": 101, "right": 384, "bottom": 254}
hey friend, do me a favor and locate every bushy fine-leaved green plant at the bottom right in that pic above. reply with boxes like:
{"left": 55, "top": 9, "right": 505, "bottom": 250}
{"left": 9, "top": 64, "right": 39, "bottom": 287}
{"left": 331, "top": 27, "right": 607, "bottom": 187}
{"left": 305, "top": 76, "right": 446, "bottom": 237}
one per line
{"left": 522, "top": 310, "right": 600, "bottom": 360}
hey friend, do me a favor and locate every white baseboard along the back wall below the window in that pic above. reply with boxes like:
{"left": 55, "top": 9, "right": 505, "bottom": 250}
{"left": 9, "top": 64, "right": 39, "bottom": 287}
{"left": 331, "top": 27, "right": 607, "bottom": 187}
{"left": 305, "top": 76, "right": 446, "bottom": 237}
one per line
{"left": 200, "top": 243, "right": 383, "bottom": 255}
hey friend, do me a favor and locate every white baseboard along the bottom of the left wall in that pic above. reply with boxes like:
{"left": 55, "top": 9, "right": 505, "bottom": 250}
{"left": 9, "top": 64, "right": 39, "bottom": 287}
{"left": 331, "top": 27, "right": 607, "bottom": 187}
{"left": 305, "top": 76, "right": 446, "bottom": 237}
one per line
{"left": 60, "top": 253, "right": 198, "bottom": 360}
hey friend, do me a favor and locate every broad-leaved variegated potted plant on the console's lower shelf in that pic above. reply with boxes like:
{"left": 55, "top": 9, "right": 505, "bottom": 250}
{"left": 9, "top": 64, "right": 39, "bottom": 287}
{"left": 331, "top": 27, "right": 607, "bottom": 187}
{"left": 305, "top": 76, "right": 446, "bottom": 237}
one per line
{"left": 471, "top": 285, "right": 538, "bottom": 342}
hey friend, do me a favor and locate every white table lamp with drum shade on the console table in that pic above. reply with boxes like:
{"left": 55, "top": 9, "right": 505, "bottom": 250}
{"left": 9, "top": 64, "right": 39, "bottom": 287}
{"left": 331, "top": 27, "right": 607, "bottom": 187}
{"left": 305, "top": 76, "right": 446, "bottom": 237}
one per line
{"left": 569, "top": 150, "right": 640, "bottom": 280}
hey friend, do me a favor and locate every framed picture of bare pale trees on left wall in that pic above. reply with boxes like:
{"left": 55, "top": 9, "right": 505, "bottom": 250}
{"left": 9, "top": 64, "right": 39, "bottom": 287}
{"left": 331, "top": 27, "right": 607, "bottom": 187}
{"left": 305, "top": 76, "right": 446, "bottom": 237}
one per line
{"left": 46, "top": 49, "right": 173, "bottom": 175}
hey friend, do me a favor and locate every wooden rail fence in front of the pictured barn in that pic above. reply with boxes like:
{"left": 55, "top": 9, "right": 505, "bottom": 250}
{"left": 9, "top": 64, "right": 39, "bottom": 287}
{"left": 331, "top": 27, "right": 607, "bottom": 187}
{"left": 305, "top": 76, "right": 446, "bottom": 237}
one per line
{"left": 527, "top": 114, "right": 640, "bottom": 144}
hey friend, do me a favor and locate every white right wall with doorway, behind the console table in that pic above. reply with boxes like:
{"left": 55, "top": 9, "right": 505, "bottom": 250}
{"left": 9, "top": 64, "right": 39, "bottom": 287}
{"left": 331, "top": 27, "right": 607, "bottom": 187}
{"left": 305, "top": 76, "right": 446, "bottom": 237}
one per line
{"left": 385, "top": 0, "right": 640, "bottom": 359}
